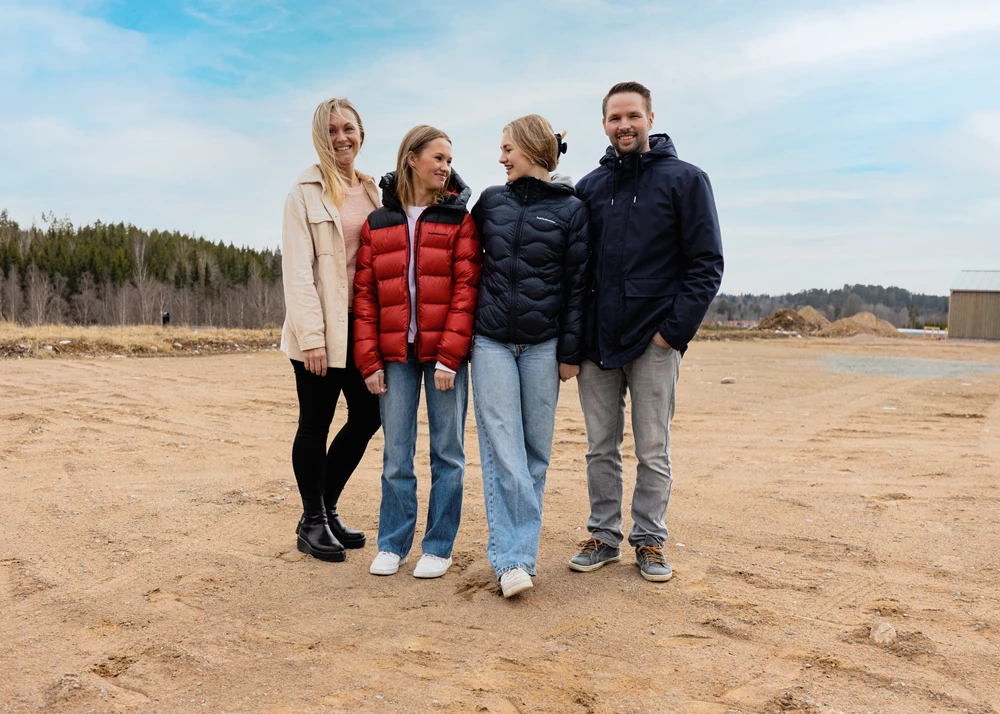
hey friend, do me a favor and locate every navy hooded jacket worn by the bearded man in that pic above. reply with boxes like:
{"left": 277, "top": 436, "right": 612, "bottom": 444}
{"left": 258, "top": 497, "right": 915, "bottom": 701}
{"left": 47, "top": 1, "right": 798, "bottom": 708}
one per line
{"left": 576, "top": 134, "right": 723, "bottom": 369}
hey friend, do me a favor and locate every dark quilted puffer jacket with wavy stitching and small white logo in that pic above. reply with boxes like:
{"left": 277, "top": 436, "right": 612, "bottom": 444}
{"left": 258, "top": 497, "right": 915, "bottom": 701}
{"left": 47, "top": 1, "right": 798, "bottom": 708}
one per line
{"left": 472, "top": 175, "right": 590, "bottom": 364}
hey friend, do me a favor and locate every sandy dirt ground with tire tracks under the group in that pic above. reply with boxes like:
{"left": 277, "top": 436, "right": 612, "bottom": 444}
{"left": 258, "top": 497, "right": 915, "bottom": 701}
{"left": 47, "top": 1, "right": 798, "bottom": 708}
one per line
{"left": 0, "top": 338, "right": 1000, "bottom": 714}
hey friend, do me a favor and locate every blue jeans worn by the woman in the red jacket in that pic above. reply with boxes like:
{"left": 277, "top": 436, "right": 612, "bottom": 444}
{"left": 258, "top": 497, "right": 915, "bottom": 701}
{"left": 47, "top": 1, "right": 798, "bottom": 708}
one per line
{"left": 378, "top": 353, "right": 469, "bottom": 558}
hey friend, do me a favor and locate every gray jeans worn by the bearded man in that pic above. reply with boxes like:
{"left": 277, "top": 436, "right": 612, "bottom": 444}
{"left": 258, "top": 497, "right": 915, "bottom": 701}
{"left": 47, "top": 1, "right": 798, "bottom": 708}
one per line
{"left": 578, "top": 342, "right": 681, "bottom": 547}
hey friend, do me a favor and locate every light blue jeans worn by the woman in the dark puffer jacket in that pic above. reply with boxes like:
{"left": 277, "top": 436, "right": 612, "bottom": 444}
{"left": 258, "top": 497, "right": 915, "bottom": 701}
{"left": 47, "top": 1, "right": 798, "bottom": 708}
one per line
{"left": 472, "top": 335, "right": 559, "bottom": 577}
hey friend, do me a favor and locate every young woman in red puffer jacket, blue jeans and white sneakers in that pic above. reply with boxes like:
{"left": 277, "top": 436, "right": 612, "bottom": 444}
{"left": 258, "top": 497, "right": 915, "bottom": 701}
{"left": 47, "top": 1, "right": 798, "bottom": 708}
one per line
{"left": 354, "top": 125, "right": 481, "bottom": 578}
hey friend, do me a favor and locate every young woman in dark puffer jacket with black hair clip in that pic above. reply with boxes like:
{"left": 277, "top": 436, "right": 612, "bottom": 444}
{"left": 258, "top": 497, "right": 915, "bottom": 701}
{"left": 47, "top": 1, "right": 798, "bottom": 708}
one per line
{"left": 472, "top": 114, "right": 590, "bottom": 597}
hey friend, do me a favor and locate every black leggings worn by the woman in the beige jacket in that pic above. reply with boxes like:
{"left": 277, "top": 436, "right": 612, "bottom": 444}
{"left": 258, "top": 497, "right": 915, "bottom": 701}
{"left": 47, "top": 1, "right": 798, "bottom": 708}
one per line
{"left": 292, "top": 334, "right": 382, "bottom": 513}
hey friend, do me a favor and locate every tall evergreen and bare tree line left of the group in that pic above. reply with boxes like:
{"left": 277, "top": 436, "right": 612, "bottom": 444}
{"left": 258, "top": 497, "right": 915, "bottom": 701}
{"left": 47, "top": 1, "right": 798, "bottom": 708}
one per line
{"left": 0, "top": 210, "right": 285, "bottom": 328}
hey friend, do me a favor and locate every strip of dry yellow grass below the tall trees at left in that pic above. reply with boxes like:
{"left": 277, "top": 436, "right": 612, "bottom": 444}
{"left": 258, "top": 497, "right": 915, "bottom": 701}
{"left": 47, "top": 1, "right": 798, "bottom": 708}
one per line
{"left": 0, "top": 322, "right": 281, "bottom": 358}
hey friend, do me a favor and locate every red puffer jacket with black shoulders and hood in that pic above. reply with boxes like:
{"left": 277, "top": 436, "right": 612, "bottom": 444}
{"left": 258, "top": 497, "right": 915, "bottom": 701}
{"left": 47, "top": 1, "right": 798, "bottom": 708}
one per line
{"left": 354, "top": 171, "right": 482, "bottom": 379}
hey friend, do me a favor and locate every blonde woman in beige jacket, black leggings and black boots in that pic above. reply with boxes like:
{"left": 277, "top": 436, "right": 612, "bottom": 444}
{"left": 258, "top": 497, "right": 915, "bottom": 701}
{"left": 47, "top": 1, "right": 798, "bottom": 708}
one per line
{"left": 281, "top": 99, "right": 381, "bottom": 561}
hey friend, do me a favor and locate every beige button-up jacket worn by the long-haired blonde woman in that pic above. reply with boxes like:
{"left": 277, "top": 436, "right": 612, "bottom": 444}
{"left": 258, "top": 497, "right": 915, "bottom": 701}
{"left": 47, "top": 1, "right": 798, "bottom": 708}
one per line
{"left": 281, "top": 165, "right": 382, "bottom": 368}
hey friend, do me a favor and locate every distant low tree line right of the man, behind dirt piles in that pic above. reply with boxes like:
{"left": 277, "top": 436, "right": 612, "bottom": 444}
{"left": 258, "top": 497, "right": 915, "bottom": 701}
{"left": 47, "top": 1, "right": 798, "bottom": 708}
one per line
{"left": 706, "top": 285, "right": 948, "bottom": 327}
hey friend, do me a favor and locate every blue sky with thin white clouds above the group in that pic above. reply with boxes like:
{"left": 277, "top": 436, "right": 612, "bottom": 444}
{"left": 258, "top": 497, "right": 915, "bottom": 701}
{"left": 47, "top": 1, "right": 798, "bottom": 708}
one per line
{"left": 0, "top": 0, "right": 1000, "bottom": 295}
